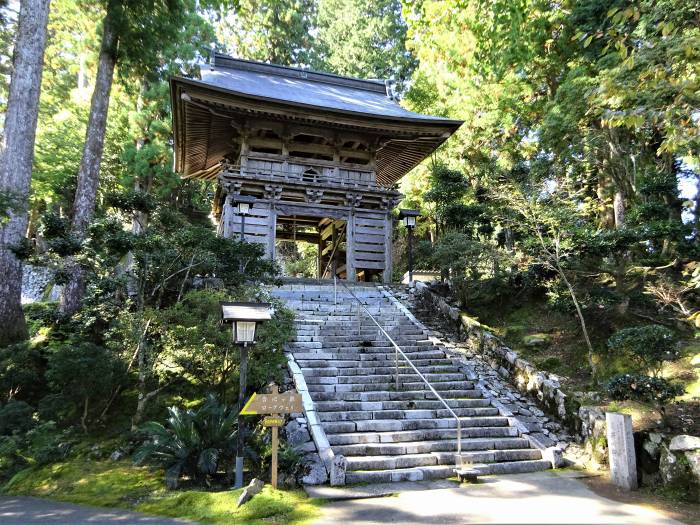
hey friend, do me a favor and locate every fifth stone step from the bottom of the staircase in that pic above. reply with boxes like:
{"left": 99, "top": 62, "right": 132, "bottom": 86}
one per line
{"left": 322, "top": 416, "right": 508, "bottom": 435}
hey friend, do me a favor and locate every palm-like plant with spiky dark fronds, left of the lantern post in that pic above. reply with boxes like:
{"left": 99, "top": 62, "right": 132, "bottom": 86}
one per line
{"left": 134, "top": 395, "right": 238, "bottom": 488}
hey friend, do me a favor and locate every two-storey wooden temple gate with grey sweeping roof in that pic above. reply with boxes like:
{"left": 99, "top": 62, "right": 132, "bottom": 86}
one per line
{"left": 170, "top": 54, "right": 462, "bottom": 282}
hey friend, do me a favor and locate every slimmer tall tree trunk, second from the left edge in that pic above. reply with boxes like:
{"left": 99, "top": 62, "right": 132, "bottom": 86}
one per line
{"left": 61, "top": 13, "right": 119, "bottom": 315}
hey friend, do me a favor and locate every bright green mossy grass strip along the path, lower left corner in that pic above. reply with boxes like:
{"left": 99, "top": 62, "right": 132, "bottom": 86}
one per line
{"left": 1, "top": 458, "right": 320, "bottom": 524}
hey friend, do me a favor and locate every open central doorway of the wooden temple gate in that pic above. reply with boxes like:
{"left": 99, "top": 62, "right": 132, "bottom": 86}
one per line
{"left": 275, "top": 215, "right": 347, "bottom": 279}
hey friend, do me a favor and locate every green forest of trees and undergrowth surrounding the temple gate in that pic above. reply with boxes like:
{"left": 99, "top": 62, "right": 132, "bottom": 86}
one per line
{"left": 0, "top": 0, "right": 700, "bottom": 512}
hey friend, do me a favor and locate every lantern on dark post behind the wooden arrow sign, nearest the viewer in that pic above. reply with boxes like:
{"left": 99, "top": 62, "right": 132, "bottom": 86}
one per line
{"left": 220, "top": 302, "right": 272, "bottom": 488}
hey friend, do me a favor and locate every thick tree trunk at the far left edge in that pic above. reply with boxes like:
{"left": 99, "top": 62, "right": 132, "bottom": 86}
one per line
{"left": 0, "top": 0, "right": 50, "bottom": 346}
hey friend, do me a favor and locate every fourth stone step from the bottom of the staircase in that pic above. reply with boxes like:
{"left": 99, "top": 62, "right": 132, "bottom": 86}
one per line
{"left": 327, "top": 426, "right": 519, "bottom": 445}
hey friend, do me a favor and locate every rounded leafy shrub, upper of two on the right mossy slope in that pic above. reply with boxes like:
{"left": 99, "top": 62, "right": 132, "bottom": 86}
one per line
{"left": 608, "top": 325, "right": 680, "bottom": 377}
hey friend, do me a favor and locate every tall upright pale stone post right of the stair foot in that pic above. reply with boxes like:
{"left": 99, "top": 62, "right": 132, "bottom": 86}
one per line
{"left": 605, "top": 412, "right": 637, "bottom": 490}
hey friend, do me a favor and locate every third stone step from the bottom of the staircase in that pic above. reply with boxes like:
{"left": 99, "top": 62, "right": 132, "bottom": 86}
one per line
{"left": 333, "top": 437, "right": 529, "bottom": 456}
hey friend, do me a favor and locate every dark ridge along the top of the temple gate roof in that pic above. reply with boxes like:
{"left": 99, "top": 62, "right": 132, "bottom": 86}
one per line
{"left": 213, "top": 53, "right": 389, "bottom": 98}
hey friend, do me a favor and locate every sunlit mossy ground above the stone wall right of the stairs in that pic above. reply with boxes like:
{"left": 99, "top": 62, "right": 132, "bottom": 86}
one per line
{"left": 466, "top": 299, "right": 700, "bottom": 434}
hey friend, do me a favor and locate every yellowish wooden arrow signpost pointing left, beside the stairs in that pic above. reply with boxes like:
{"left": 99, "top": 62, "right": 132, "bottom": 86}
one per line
{"left": 240, "top": 384, "right": 302, "bottom": 489}
